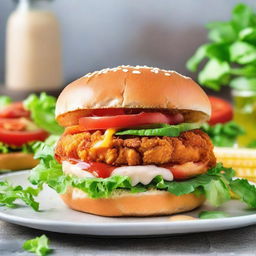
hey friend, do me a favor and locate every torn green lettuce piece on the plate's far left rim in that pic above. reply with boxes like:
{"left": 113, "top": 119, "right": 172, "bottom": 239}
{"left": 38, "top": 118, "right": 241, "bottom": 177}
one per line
{"left": 0, "top": 181, "right": 41, "bottom": 211}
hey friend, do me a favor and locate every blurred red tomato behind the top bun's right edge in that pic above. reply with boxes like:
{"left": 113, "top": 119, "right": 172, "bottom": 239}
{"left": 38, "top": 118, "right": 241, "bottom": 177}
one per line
{"left": 208, "top": 96, "right": 233, "bottom": 125}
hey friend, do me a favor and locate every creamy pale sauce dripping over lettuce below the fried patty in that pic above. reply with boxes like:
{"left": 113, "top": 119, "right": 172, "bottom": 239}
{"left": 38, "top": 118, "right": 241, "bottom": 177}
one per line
{"left": 111, "top": 165, "right": 173, "bottom": 186}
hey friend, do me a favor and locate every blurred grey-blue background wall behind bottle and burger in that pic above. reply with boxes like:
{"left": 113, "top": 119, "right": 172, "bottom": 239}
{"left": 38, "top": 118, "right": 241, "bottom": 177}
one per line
{"left": 0, "top": 0, "right": 256, "bottom": 93}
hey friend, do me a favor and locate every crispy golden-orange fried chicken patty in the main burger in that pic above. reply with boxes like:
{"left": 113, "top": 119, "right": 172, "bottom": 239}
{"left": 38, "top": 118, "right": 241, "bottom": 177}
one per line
{"left": 55, "top": 130, "right": 216, "bottom": 168}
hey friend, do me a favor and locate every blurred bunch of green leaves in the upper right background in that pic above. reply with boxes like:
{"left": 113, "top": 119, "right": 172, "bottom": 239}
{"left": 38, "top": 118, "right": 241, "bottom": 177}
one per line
{"left": 187, "top": 3, "right": 256, "bottom": 90}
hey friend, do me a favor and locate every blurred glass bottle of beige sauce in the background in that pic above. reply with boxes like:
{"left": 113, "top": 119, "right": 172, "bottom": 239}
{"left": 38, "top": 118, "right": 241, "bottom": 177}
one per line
{"left": 6, "top": 0, "right": 63, "bottom": 91}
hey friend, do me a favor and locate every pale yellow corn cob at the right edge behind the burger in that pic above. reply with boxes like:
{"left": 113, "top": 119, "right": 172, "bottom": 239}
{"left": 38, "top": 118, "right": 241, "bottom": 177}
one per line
{"left": 214, "top": 147, "right": 256, "bottom": 182}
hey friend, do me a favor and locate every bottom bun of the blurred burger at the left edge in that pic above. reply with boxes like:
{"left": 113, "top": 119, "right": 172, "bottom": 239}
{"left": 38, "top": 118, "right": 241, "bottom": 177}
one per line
{"left": 0, "top": 152, "right": 38, "bottom": 171}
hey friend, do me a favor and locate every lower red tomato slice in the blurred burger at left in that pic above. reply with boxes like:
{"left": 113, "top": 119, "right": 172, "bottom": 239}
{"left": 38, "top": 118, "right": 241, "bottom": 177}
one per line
{"left": 0, "top": 128, "right": 49, "bottom": 147}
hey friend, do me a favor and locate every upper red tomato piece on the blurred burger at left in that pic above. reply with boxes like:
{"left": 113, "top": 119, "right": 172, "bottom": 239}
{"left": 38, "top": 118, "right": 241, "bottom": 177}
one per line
{"left": 0, "top": 102, "right": 30, "bottom": 118}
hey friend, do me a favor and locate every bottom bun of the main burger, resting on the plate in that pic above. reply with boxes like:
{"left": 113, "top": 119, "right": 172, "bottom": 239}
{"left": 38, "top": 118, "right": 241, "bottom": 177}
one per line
{"left": 61, "top": 188, "right": 205, "bottom": 217}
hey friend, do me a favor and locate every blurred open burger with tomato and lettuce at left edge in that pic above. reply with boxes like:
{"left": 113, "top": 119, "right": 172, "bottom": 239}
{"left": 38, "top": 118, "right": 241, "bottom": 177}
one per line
{"left": 0, "top": 93, "right": 62, "bottom": 170}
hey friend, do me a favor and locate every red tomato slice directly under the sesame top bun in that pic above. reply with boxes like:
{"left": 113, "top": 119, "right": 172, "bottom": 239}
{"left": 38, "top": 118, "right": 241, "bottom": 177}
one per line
{"left": 79, "top": 112, "right": 184, "bottom": 130}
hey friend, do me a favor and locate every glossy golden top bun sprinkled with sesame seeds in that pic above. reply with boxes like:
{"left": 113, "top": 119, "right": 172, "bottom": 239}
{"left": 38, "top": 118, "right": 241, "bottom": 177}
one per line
{"left": 56, "top": 66, "right": 211, "bottom": 126}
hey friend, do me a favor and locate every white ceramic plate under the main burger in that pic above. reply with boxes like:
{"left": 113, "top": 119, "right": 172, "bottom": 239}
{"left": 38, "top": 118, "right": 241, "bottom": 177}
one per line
{"left": 0, "top": 171, "right": 256, "bottom": 236}
